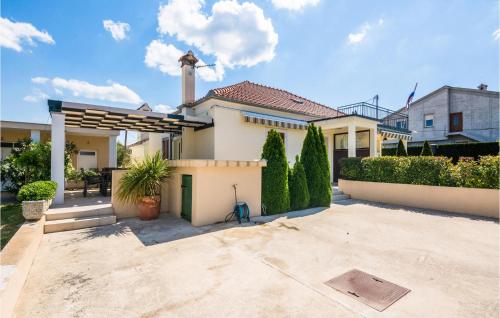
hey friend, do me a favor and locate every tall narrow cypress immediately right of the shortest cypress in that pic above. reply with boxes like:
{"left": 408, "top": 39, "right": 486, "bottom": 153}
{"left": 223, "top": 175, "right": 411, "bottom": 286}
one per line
{"left": 300, "top": 124, "right": 321, "bottom": 207}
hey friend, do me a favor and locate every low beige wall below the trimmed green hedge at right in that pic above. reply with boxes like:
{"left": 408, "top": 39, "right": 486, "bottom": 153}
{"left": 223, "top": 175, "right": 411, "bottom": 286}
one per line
{"left": 339, "top": 179, "right": 500, "bottom": 219}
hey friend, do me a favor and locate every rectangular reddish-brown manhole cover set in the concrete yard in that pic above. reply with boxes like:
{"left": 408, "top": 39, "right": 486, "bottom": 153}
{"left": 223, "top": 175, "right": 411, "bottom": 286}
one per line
{"left": 325, "top": 269, "right": 410, "bottom": 311}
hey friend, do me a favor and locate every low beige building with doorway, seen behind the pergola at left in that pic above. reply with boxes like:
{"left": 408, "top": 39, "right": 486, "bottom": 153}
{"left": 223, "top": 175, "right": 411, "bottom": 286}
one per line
{"left": 0, "top": 120, "right": 119, "bottom": 173}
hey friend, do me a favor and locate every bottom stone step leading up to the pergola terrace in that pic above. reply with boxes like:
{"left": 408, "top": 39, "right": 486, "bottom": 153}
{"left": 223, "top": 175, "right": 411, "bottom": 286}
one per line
{"left": 44, "top": 215, "right": 116, "bottom": 233}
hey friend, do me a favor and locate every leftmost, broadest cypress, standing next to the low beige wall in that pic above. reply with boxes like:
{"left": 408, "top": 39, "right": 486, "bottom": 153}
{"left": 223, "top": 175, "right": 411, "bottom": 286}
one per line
{"left": 262, "top": 130, "right": 290, "bottom": 214}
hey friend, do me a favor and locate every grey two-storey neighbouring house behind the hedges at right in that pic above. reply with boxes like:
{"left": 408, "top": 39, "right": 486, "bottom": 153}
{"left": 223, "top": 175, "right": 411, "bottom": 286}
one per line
{"left": 408, "top": 84, "right": 500, "bottom": 145}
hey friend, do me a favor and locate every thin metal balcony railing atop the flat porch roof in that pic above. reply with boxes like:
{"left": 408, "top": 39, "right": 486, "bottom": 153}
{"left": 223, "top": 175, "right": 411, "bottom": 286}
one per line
{"left": 337, "top": 102, "right": 408, "bottom": 130}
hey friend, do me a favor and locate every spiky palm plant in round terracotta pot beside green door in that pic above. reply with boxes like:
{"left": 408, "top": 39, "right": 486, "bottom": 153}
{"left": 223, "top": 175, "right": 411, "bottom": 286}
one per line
{"left": 116, "top": 152, "right": 172, "bottom": 220}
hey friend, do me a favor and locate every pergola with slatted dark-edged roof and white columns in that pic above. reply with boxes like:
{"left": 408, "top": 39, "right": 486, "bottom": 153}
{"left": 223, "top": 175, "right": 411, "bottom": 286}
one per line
{"left": 48, "top": 100, "right": 211, "bottom": 204}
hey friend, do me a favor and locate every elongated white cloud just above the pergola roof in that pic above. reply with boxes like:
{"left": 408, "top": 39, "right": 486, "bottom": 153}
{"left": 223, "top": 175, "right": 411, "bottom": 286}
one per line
{"left": 51, "top": 77, "right": 142, "bottom": 104}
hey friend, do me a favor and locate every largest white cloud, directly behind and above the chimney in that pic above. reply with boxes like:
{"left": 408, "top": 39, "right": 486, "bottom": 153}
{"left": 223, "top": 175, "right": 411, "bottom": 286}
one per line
{"left": 152, "top": 0, "right": 278, "bottom": 80}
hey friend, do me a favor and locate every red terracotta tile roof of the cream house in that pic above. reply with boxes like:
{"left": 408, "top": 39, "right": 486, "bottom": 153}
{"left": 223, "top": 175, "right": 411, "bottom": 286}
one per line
{"left": 200, "top": 81, "right": 343, "bottom": 118}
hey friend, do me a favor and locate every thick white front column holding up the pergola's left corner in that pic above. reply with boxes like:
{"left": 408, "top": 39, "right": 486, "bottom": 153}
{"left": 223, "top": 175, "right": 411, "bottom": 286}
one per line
{"left": 50, "top": 113, "right": 65, "bottom": 204}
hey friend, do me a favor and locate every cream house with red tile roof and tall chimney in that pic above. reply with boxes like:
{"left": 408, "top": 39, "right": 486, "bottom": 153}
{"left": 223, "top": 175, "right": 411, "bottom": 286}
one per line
{"left": 130, "top": 52, "right": 409, "bottom": 181}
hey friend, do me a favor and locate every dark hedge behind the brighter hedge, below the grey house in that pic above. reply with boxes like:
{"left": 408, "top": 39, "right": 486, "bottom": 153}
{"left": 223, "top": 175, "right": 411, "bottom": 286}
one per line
{"left": 382, "top": 142, "right": 499, "bottom": 163}
